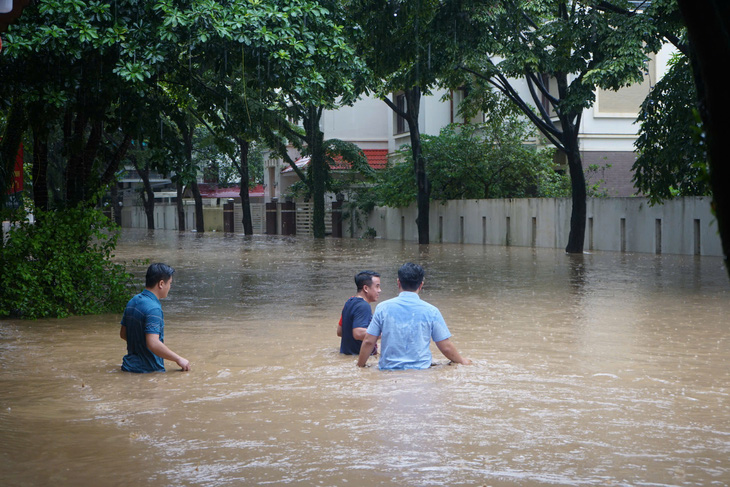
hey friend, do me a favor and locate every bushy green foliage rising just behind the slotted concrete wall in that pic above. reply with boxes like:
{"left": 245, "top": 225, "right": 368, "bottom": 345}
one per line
{"left": 373, "top": 116, "right": 568, "bottom": 207}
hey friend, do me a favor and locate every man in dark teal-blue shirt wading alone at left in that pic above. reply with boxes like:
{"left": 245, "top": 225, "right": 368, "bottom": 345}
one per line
{"left": 119, "top": 264, "right": 190, "bottom": 373}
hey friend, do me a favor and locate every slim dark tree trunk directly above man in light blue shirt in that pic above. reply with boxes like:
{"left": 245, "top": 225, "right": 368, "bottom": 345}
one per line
{"left": 405, "top": 86, "right": 431, "bottom": 244}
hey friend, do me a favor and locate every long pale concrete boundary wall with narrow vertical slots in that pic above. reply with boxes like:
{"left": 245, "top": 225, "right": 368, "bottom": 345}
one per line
{"left": 365, "top": 197, "right": 722, "bottom": 256}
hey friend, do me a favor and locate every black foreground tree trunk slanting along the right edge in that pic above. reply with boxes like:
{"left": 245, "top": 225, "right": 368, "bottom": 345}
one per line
{"left": 678, "top": 0, "right": 730, "bottom": 276}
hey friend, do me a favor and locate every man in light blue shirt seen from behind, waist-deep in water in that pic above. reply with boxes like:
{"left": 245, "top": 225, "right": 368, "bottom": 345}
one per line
{"left": 357, "top": 262, "right": 471, "bottom": 370}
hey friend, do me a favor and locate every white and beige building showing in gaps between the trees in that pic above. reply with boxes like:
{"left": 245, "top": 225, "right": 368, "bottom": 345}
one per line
{"left": 264, "top": 43, "right": 673, "bottom": 201}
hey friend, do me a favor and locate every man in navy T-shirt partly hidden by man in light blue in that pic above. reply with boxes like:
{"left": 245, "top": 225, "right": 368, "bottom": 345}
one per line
{"left": 337, "top": 271, "right": 380, "bottom": 355}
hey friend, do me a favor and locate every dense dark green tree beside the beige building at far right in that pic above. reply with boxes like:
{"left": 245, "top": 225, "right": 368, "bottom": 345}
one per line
{"left": 633, "top": 55, "right": 710, "bottom": 204}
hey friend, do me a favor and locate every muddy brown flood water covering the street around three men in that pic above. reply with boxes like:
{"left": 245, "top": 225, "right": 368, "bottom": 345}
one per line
{"left": 0, "top": 230, "right": 730, "bottom": 487}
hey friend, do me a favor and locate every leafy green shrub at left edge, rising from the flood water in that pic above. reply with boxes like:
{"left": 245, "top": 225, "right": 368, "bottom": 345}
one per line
{"left": 0, "top": 207, "right": 132, "bottom": 319}
